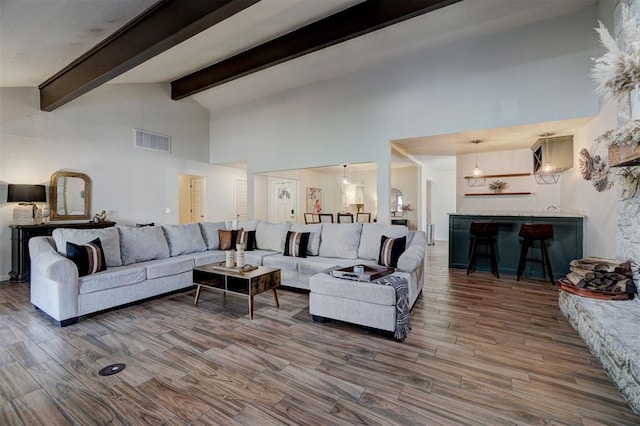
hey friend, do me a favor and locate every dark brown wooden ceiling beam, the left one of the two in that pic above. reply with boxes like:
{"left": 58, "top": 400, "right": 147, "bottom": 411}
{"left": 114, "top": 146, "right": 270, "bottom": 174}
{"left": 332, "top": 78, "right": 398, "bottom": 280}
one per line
{"left": 39, "top": 0, "right": 259, "bottom": 111}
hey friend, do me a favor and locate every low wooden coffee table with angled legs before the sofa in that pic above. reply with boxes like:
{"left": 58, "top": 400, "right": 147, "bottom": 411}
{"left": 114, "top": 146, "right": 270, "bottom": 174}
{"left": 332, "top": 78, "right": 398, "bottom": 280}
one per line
{"left": 193, "top": 262, "right": 280, "bottom": 319}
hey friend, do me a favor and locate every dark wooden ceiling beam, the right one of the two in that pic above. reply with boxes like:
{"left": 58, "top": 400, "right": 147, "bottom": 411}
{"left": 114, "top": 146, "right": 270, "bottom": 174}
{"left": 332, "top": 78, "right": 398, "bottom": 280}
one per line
{"left": 171, "top": 0, "right": 461, "bottom": 100}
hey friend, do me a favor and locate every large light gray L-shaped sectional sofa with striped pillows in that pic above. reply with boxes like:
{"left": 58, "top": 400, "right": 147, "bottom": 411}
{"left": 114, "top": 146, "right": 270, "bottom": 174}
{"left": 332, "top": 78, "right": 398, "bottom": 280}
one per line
{"left": 29, "top": 221, "right": 426, "bottom": 326}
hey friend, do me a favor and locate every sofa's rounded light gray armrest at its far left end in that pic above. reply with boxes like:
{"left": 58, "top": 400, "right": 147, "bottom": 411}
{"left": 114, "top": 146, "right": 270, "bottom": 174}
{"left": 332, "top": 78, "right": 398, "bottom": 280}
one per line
{"left": 29, "top": 237, "right": 79, "bottom": 321}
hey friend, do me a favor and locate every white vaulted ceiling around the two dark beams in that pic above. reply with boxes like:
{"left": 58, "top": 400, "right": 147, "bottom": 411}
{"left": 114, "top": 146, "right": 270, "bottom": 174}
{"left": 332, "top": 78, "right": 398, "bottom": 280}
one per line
{"left": 0, "top": 0, "right": 597, "bottom": 155}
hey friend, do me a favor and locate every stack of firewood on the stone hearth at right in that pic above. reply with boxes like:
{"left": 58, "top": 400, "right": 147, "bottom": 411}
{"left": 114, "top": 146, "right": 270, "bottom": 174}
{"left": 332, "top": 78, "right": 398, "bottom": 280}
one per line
{"left": 564, "top": 257, "right": 636, "bottom": 293}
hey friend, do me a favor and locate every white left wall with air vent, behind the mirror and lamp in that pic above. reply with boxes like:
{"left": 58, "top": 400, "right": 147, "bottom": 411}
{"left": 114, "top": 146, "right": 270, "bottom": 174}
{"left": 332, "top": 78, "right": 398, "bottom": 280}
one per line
{"left": 0, "top": 84, "right": 246, "bottom": 278}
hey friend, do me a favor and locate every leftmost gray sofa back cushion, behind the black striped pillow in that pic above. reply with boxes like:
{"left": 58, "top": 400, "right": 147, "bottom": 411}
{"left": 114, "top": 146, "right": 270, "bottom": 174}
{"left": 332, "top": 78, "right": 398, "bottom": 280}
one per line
{"left": 52, "top": 227, "right": 122, "bottom": 268}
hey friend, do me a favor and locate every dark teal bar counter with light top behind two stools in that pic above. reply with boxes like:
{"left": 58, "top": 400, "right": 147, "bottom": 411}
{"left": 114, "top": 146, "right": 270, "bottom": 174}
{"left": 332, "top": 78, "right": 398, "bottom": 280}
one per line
{"left": 449, "top": 212, "right": 585, "bottom": 280}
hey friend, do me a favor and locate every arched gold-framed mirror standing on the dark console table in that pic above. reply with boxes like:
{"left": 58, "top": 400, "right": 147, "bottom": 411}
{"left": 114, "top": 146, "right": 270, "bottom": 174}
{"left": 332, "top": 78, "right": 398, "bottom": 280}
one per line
{"left": 49, "top": 171, "right": 91, "bottom": 220}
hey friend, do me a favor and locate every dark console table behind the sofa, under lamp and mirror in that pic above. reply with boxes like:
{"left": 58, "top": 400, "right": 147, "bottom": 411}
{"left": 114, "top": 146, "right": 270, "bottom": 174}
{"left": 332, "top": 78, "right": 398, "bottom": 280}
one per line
{"left": 9, "top": 221, "right": 116, "bottom": 282}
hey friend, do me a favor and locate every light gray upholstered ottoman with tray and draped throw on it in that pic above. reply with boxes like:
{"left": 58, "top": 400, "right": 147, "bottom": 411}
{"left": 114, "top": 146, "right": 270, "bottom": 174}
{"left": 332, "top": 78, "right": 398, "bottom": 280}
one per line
{"left": 309, "top": 272, "right": 402, "bottom": 332}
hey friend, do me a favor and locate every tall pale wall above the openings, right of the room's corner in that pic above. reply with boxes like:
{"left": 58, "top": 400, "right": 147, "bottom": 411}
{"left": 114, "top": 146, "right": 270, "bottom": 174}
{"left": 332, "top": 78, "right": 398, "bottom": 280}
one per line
{"left": 211, "top": 7, "right": 600, "bottom": 221}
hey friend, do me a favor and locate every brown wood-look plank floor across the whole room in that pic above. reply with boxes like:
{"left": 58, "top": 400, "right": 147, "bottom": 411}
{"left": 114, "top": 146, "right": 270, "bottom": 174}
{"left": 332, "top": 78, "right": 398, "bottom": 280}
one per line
{"left": 0, "top": 243, "right": 640, "bottom": 425}
